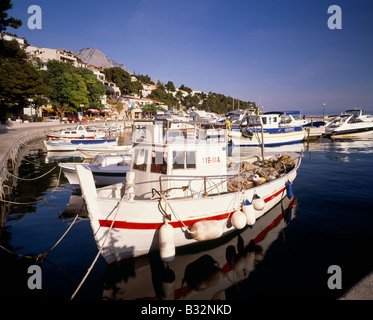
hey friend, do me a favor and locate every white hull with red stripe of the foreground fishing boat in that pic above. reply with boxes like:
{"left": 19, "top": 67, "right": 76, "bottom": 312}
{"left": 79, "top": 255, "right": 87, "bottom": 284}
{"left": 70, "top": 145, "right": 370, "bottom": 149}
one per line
{"left": 78, "top": 160, "right": 300, "bottom": 263}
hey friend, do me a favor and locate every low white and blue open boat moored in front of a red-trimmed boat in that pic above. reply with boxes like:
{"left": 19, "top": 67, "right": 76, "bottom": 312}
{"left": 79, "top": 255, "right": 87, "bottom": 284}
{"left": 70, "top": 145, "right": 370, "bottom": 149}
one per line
{"left": 43, "top": 139, "right": 118, "bottom": 151}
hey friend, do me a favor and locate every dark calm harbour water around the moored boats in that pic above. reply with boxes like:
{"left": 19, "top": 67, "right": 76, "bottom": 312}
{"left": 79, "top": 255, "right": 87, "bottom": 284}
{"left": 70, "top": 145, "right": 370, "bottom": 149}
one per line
{"left": 0, "top": 134, "right": 373, "bottom": 300}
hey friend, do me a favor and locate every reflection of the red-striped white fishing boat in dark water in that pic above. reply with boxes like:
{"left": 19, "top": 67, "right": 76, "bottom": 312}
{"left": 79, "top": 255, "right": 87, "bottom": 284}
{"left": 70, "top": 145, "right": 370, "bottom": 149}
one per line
{"left": 102, "top": 197, "right": 298, "bottom": 300}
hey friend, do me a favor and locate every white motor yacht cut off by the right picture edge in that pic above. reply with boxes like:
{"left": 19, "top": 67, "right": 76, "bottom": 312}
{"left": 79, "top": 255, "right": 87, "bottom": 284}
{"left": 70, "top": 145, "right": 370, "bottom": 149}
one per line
{"left": 325, "top": 108, "right": 373, "bottom": 139}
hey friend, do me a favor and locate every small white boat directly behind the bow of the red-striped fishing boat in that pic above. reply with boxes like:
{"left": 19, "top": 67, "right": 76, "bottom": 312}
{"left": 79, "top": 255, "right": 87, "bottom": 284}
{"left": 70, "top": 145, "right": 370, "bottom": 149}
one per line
{"left": 58, "top": 153, "right": 132, "bottom": 186}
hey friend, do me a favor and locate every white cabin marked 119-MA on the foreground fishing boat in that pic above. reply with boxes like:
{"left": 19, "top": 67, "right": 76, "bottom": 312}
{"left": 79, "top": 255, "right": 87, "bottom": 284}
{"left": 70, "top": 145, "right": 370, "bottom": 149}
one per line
{"left": 131, "top": 124, "right": 227, "bottom": 199}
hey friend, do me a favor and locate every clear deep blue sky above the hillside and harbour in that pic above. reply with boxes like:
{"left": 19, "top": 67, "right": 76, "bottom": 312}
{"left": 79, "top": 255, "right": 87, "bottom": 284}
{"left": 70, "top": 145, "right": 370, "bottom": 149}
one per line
{"left": 7, "top": 0, "right": 373, "bottom": 114}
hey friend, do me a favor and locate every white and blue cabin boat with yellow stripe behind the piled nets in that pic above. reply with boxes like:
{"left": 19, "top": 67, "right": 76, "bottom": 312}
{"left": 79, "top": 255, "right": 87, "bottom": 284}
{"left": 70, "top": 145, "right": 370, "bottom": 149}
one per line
{"left": 228, "top": 112, "right": 305, "bottom": 146}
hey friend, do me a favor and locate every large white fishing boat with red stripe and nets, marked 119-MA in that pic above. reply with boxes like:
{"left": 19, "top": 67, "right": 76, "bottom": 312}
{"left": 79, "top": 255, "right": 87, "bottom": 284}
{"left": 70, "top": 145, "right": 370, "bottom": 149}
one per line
{"left": 76, "top": 124, "right": 301, "bottom": 263}
